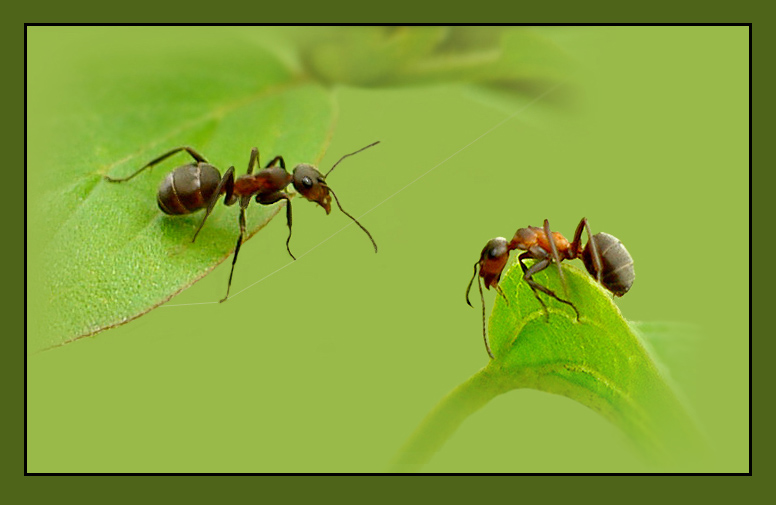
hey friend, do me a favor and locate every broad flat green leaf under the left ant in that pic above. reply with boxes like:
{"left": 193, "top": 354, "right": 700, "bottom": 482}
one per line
{"left": 28, "top": 30, "right": 335, "bottom": 351}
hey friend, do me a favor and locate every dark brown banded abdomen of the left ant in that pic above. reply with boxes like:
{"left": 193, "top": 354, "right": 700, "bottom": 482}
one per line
{"left": 156, "top": 163, "right": 221, "bottom": 215}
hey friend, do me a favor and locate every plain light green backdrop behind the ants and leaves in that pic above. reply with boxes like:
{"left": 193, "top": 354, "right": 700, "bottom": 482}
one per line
{"left": 27, "top": 27, "right": 749, "bottom": 472}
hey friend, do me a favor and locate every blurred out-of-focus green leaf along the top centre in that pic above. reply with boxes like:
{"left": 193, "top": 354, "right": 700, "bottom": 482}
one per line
{"left": 290, "top": 26, "right": 571, "bottom": 94}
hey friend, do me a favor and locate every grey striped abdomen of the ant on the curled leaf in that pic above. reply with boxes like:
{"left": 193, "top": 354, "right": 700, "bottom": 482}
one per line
{"left": 582, "top": 233, "right": 636, "bottom": 296}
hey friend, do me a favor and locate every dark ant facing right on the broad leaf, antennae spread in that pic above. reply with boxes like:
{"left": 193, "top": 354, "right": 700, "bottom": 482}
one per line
{"left": 105, "top": 141, "right": 380, "bottom": 302}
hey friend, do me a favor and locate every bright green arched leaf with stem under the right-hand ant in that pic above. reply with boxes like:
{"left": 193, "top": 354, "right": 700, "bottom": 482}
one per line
{"left": 394, "top": 264, "right": 704, "bottom": 471}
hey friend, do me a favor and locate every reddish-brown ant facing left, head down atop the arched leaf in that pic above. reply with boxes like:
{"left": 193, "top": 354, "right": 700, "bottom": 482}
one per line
{"left": 466, "top": 218, "right": 636, "bottom": 358}
